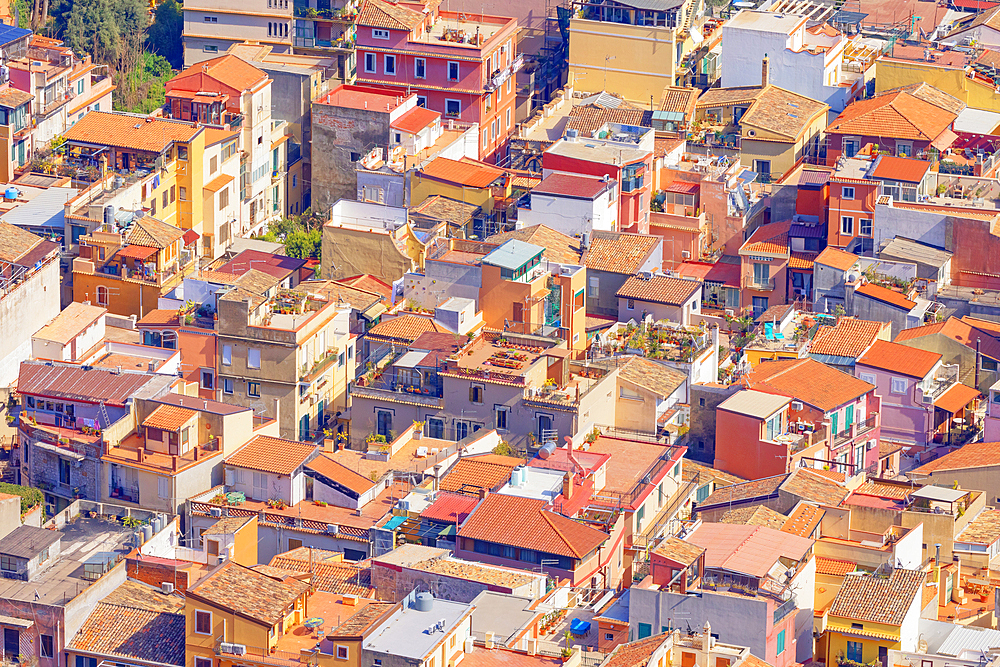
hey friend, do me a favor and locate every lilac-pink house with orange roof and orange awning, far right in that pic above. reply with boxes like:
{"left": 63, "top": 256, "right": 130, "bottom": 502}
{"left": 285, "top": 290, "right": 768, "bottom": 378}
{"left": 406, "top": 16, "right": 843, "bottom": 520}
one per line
{"left": 854, "top": 340, "right": 988, "bottom": 446}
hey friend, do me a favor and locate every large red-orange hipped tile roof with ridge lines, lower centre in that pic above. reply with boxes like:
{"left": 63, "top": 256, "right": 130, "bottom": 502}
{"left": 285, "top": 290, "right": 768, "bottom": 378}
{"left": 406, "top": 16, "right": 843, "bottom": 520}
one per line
{"left": 458, "top": 493, "right": 609, "bottom": 558}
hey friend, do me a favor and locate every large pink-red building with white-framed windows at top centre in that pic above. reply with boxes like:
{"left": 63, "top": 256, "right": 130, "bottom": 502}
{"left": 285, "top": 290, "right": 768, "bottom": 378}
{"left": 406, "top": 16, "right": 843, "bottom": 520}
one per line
{"left": 356, "top": 0, "right": 523, "bottom": 162}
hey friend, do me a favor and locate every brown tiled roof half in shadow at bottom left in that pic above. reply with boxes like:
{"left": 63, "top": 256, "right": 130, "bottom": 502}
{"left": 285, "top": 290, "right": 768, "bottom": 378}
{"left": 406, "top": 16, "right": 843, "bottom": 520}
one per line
{"left": 66, "top": 602, "right": 185, "bottom": 666}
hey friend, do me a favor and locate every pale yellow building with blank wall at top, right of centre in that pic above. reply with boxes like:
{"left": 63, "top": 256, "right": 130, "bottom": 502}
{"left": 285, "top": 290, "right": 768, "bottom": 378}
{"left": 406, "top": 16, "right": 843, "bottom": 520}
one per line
{"left": 569, "top": 0, "right": 702, "bottom": 105}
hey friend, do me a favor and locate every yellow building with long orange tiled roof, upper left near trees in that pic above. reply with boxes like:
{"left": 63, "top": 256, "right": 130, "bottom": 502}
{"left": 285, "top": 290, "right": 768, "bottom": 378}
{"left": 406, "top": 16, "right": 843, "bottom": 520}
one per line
{"left": 64, "top": 111, "right": 241, "bottom": 258}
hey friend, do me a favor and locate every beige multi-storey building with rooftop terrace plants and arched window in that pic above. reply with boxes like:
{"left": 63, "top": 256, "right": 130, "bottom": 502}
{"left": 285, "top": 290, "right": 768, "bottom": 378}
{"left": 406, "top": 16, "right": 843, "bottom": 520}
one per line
{"left": 217, "top": 287, "right": 355, "bottom": 440}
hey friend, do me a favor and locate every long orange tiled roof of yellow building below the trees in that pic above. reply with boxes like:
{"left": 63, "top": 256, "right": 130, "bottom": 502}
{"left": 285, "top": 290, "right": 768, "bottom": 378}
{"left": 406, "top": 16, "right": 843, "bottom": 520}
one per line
{"left": 63, "top": 111, "right": 201, "bottom": 153}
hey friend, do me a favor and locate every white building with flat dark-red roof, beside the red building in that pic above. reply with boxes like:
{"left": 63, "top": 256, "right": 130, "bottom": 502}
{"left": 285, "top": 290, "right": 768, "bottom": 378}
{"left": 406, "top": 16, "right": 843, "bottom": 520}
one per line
{"left": 517, "top": 172, "right": 618, "bottom": 236}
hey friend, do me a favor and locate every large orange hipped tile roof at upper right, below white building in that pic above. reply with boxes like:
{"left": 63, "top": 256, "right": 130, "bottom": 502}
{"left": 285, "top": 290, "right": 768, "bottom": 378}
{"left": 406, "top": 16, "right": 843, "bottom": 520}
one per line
{"left": 826, "top": 90, "right": 958, "bottom": 141}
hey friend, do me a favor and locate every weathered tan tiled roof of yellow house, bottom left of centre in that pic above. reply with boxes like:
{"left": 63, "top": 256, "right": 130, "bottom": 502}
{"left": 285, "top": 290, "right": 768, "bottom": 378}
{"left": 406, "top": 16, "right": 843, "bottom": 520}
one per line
{"left": 187, "top": 561, "right": 309, "bottom": 626}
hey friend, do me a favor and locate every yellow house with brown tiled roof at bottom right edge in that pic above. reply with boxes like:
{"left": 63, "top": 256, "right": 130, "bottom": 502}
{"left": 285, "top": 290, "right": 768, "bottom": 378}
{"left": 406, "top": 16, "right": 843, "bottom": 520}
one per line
{"left": 816, "top": 565, "right": 927, "bottom": 667}
